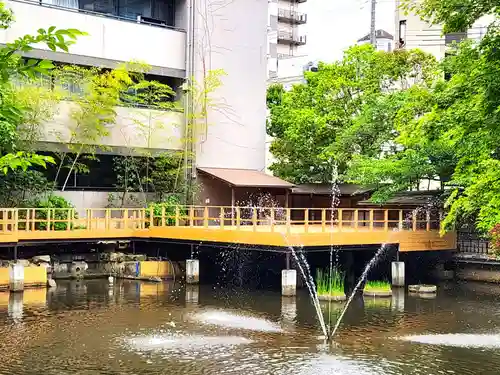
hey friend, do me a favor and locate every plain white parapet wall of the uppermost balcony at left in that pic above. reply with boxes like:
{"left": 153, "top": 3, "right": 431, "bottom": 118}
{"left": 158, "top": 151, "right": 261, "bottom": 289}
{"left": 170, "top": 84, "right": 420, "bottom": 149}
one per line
{"left": 0, "top": 0, "right": 186, "bottom": 70}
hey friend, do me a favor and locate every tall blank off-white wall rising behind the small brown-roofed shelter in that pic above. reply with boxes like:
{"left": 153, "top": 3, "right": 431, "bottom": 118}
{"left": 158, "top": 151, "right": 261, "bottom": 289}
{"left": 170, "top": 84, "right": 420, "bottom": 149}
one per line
{"left": 195, "top": 0, "right": 268, "bottom": 170}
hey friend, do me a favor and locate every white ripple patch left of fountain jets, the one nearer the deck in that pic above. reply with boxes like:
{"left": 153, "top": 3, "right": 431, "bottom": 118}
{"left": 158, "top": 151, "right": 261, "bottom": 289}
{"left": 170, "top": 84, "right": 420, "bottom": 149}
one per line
{"left": 195, "top": 311, "right": 282, "bottom": 332}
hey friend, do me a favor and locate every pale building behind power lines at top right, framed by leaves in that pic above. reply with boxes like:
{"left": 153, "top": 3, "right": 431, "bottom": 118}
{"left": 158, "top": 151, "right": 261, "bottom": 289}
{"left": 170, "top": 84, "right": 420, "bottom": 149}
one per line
{"left": 394, "top": 0, "right": 493, "bottom": 60}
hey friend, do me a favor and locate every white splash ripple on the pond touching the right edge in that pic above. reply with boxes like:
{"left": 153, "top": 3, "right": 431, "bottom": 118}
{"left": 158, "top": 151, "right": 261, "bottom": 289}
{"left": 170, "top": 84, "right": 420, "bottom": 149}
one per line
{"left": 399, "top": 333, "right": 500, "bottom": 349}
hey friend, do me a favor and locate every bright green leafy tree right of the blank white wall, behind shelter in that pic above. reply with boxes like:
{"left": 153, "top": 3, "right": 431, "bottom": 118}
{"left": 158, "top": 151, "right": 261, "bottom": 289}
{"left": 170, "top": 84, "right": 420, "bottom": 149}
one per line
{"left": 267, "top": 45, "right": 436, "bottom": 183}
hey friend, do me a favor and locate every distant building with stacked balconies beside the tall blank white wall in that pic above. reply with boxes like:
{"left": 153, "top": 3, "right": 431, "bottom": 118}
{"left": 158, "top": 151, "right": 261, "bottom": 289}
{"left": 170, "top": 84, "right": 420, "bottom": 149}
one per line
{"left": 267, "top": 0, "right": 307, "bottom": 79}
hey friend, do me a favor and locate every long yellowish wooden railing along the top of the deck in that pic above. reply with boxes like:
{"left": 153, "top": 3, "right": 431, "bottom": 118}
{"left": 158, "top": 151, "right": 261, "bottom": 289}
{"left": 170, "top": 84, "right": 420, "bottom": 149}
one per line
{"left": 0, "top": 206, "right": 440, "bottom": 233}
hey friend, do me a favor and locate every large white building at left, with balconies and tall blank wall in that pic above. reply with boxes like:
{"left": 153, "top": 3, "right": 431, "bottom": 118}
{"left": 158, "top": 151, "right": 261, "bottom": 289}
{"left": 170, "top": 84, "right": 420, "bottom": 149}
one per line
{"left": 0, "top": 0, "right": 274, "bottom": 208}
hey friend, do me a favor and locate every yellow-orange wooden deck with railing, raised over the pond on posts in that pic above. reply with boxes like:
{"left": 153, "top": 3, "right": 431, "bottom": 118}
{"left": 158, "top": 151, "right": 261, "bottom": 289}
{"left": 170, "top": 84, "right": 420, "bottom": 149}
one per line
{"left": 0, "top": 206, "right": 456, "bottom": 251}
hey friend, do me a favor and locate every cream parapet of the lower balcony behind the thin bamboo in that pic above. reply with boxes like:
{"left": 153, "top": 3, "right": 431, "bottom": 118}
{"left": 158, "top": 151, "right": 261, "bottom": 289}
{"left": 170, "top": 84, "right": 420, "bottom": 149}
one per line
{"left": 41, "top": 102, "right": 184, "bottom": 151}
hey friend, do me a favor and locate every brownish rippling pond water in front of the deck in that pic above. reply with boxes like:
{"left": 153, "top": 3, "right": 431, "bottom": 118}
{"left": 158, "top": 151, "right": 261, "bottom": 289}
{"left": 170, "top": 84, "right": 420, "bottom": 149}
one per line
{"left": 0, "top": 280, "right": 500, "bottom": 375}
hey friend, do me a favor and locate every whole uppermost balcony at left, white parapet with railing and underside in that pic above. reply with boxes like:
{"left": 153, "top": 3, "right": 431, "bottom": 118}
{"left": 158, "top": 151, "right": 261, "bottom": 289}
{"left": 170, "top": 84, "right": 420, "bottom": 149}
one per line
{"left": 0, "top": 0, "right": 186, "bottom": 78}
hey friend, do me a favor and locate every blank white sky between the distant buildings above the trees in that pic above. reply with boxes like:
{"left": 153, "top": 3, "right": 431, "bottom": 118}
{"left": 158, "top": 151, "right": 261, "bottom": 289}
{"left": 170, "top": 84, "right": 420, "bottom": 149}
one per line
{"left": 304, "top": 0, "right": 395, "bottom": 62}
